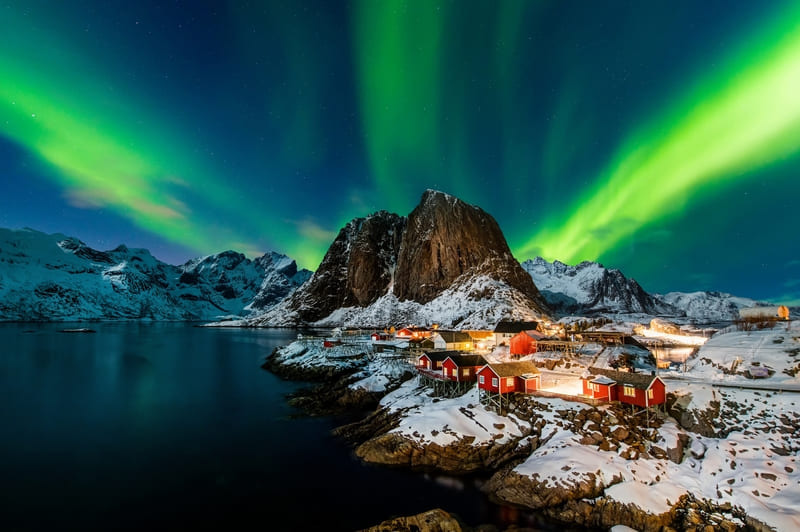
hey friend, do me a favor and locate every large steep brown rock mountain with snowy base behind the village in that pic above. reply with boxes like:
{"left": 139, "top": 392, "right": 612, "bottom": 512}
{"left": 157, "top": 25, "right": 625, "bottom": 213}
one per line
{"left": 248, "top": 190, "right": 549, "bottom": 328}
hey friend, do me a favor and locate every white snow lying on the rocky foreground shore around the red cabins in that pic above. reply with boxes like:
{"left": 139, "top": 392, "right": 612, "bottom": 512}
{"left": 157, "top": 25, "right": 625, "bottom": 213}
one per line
{"left": 304, "top": 322, "right": 800, "bottom": 530}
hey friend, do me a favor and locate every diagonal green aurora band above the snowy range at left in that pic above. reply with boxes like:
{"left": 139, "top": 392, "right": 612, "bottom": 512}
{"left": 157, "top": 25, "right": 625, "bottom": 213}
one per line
{"left": 0, "top": 11, "right": 329, "bottom": 267}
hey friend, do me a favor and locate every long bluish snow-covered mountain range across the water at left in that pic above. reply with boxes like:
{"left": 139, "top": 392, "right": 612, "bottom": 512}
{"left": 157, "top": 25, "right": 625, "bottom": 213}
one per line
{"left": 0, "top": 229, "right": 311, "bottom": 321}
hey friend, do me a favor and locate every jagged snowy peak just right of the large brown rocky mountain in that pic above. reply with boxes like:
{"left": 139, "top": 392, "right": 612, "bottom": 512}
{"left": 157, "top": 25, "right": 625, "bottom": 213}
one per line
{"left": 522, "top": 257, "right": 676, "bottom": 315}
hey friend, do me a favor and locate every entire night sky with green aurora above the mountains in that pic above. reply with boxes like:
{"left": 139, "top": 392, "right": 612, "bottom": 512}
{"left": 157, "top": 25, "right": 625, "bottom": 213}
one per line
{"left": 0, "top": 0, "right": 800, "bottom": 304}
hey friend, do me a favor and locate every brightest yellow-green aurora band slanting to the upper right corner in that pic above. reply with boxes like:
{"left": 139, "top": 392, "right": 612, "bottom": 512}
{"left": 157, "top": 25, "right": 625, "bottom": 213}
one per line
{"left": 514, "top": 5, "right": 800, "bottom": 263}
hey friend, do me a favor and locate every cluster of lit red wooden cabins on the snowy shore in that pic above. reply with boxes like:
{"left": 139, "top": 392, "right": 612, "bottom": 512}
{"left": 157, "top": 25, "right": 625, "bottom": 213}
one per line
{"left": 364, "top": 321, "right": 666, "bottom": 416}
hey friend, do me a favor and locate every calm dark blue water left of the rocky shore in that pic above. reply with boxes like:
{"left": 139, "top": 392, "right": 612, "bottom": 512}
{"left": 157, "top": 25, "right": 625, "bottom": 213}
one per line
{"left": 0, "top": 322, "right": 580, "bottom": 530}
